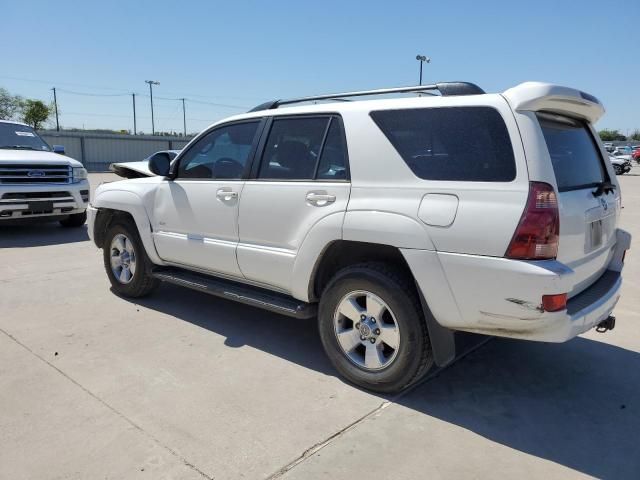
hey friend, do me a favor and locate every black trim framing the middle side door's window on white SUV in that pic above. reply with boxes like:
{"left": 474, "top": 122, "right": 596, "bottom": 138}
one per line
{"left": 248, "top": 112, "right": 351, "bottom": 183}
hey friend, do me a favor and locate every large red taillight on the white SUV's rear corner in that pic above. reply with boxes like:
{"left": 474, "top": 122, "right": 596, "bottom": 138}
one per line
{"left": 505, "top": 182, "right": 560, "bottom": 260}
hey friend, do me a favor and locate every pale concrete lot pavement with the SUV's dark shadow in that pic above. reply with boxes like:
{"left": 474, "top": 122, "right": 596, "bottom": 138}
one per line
{"left": 0, "top": 172, "right": 640, "bottom": 480}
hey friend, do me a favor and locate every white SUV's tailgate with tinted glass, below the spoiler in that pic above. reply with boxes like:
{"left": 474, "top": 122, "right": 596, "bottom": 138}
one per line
{"left": 536, "top": 113, "right": 620, "bottom": 295}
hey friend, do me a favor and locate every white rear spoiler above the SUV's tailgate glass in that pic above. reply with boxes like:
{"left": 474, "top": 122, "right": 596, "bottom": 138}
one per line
{"left": 502, "top": 82, "right": 605, "bottom": 123}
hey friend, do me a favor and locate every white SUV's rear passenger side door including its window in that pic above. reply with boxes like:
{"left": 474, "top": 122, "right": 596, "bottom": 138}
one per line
{"left": 237, "top": 115, "right": 351, "bottom": 292}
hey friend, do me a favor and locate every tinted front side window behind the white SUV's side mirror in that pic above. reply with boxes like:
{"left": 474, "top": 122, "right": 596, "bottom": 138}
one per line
{"left": 178, "top": 122, "right": 260, "bottom": 180}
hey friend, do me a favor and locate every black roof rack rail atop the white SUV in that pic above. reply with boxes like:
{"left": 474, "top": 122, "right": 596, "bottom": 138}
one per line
{"left": 249, "top": 82, "right": 485, "bottom": 112}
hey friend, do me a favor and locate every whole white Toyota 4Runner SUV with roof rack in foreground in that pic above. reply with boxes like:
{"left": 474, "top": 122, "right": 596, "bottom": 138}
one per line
{"left": 88, "top": 83, "right": 630, "bottom": 392}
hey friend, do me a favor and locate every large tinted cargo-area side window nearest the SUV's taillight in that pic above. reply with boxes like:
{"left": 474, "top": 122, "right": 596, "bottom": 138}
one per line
{"left": 371, "top": 107, "right": 516, "bottom": 182}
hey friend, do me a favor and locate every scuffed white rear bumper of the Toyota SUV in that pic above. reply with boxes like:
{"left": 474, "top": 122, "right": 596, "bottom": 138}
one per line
{"left": 405, "top": 230, "right": 631, "bottom": 342}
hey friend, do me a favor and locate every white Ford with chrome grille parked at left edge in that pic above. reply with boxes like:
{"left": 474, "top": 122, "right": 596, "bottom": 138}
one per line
{"left": 0, "top": 120, "right": 89, "bottom": 227}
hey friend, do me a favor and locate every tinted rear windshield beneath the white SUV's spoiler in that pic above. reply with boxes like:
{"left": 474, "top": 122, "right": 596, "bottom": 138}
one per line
{"left": 537, "top": 113, "right": 605, "bottom": 192}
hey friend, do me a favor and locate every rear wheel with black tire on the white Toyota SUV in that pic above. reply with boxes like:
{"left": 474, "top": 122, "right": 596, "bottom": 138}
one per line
{"left": 318, "top": 262, "right": 433, "bottom": 393}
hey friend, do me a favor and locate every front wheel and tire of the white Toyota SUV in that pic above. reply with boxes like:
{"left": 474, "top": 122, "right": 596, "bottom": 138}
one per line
{"left": 102, "top": 221, "right": 160, "bottom": 298}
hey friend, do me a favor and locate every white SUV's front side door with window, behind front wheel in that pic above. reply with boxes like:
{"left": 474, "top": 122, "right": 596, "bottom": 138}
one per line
{"left": 153, "top": 120, "right": 260, "bottom": 277}
